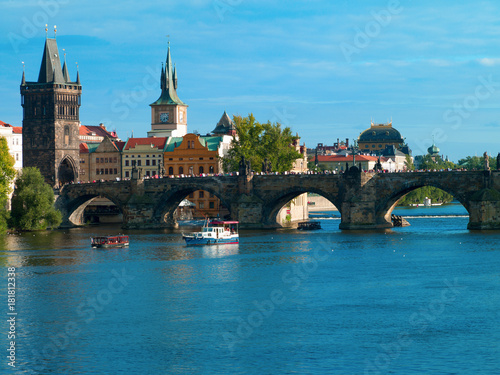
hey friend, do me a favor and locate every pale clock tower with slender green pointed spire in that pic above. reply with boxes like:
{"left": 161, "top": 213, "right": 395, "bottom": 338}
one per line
{"left": 148, "top": 43, "right": 188, "bottom": 137}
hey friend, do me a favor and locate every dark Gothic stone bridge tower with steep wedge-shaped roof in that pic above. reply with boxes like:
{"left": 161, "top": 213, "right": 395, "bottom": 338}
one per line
{"left": 21, "top": 34, "right": 82, "bottom": 187}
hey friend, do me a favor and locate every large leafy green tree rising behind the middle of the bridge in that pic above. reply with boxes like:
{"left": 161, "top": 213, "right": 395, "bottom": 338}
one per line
{"left": 222, "top": 114, "right": 302, "bottom": 172}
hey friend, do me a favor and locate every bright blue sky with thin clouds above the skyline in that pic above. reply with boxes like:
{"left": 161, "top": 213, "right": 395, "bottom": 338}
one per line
{"left": 0, "top": 0, "right": 500, "bottom": 161}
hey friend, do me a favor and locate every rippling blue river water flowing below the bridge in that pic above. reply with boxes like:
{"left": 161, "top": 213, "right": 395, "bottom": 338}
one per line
{"left": 0, "top": 205, "right": 500, "bottom": 374}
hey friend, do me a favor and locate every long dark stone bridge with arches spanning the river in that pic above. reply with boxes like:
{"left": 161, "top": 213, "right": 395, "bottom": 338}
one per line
{"left": 56, "top": 167, "right": 500, "bottom": 230}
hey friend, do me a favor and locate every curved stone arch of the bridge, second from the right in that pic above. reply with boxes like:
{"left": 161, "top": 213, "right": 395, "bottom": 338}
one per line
{"left": 262, "top": 186, "right": 342, "bottom": 227}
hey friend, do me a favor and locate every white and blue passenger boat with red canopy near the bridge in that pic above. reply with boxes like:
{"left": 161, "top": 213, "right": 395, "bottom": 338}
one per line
{"left": 182, "top": 220, "right": 239, "bottom": 245}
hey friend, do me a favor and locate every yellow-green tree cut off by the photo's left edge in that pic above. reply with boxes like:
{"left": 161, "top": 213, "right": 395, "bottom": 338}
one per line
{"left": 0, "top": 137, "right": 16, "bottom": 233}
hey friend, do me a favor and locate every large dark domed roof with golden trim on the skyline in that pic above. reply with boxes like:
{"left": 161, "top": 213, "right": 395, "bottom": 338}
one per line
{"left": 358, "top": 121, "right": 407, "bottom": 154}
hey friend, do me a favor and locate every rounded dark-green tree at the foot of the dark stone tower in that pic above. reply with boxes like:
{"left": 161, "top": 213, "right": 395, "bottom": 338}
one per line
{"left": 11, "top": 167, "right": 62, "bottom": 231}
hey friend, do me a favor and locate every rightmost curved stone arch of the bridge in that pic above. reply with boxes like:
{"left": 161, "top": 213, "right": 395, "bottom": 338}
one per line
{"left": 376, "top": 179, "right": 470, "bottom": 223}
